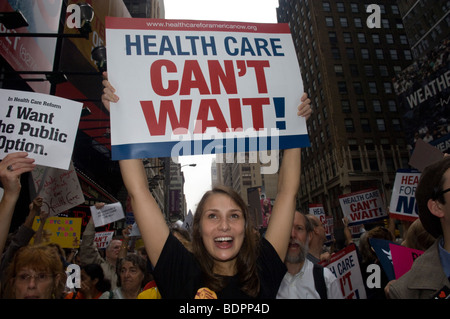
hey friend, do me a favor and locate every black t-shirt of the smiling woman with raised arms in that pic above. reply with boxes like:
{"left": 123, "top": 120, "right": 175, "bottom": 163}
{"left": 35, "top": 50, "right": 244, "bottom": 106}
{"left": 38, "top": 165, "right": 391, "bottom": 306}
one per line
{"left": 153, "top": 234, "right": 287, "bottom": 299}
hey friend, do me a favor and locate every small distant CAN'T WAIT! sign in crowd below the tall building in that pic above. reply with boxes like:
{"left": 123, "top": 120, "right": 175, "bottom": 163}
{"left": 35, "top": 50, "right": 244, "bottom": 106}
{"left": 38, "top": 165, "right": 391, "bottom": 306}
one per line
{"left": 339, "top": 189, "right": 387, "bottom": 225}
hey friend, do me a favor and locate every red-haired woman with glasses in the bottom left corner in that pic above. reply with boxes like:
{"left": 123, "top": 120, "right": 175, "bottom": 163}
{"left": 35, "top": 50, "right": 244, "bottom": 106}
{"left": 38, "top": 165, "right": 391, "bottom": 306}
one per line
{"left": 4, "top": 246, "right": 66, "bottom": 299}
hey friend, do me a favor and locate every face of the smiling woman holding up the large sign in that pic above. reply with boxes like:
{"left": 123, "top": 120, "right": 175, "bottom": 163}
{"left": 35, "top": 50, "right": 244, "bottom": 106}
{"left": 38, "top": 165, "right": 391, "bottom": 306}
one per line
{"left": 200, "top": 194, "right": 245, "bottom": 270}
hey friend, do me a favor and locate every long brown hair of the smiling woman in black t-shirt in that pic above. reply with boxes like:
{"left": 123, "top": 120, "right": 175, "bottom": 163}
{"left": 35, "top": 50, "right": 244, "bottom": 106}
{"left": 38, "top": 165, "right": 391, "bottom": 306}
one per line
{"left": 192, "top": 186, "right": 260, "bottom": 297}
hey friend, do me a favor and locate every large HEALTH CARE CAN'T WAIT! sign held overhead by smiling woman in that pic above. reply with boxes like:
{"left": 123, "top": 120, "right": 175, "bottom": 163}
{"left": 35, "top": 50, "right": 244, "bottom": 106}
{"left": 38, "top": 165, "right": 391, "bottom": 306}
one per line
{"left": 106, "top": 17, "right": 309, "bottom": 159}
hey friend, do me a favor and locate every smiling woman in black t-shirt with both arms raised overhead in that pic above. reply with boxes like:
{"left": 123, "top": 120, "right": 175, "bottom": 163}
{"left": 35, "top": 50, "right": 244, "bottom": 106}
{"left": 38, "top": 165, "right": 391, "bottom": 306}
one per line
{"left": 102, "top": 74, "right": 311, "bottom": 299}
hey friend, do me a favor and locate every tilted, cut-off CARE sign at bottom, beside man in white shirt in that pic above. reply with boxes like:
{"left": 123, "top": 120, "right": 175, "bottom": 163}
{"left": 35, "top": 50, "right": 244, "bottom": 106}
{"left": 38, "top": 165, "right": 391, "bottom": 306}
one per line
{"left": 324, "top": 244, "right": 366, "bottom": 299}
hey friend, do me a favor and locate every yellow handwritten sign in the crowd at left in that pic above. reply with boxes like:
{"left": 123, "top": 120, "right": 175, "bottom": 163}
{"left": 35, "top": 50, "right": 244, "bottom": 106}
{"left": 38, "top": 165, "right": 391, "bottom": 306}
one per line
{"left": 32, "top": 216, "right": 81, "bottom": 248}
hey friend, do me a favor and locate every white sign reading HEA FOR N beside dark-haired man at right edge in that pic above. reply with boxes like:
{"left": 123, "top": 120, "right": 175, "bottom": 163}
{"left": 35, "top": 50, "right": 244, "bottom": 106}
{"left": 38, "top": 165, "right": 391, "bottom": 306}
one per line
{"left": 389, "top": 169, "right": 421, "bottom": 221}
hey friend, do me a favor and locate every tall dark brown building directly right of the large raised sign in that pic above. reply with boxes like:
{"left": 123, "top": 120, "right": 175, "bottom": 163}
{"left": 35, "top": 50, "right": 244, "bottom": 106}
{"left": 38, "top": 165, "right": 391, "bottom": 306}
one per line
{"left": 277, "top": 0, "right": 412, "bottom": 223}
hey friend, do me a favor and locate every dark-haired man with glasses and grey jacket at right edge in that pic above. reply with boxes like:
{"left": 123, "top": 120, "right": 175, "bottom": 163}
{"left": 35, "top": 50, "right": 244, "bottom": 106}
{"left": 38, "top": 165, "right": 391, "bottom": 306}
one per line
{"left": 386, "top": 156, "right": 450, "bottom": 299}
